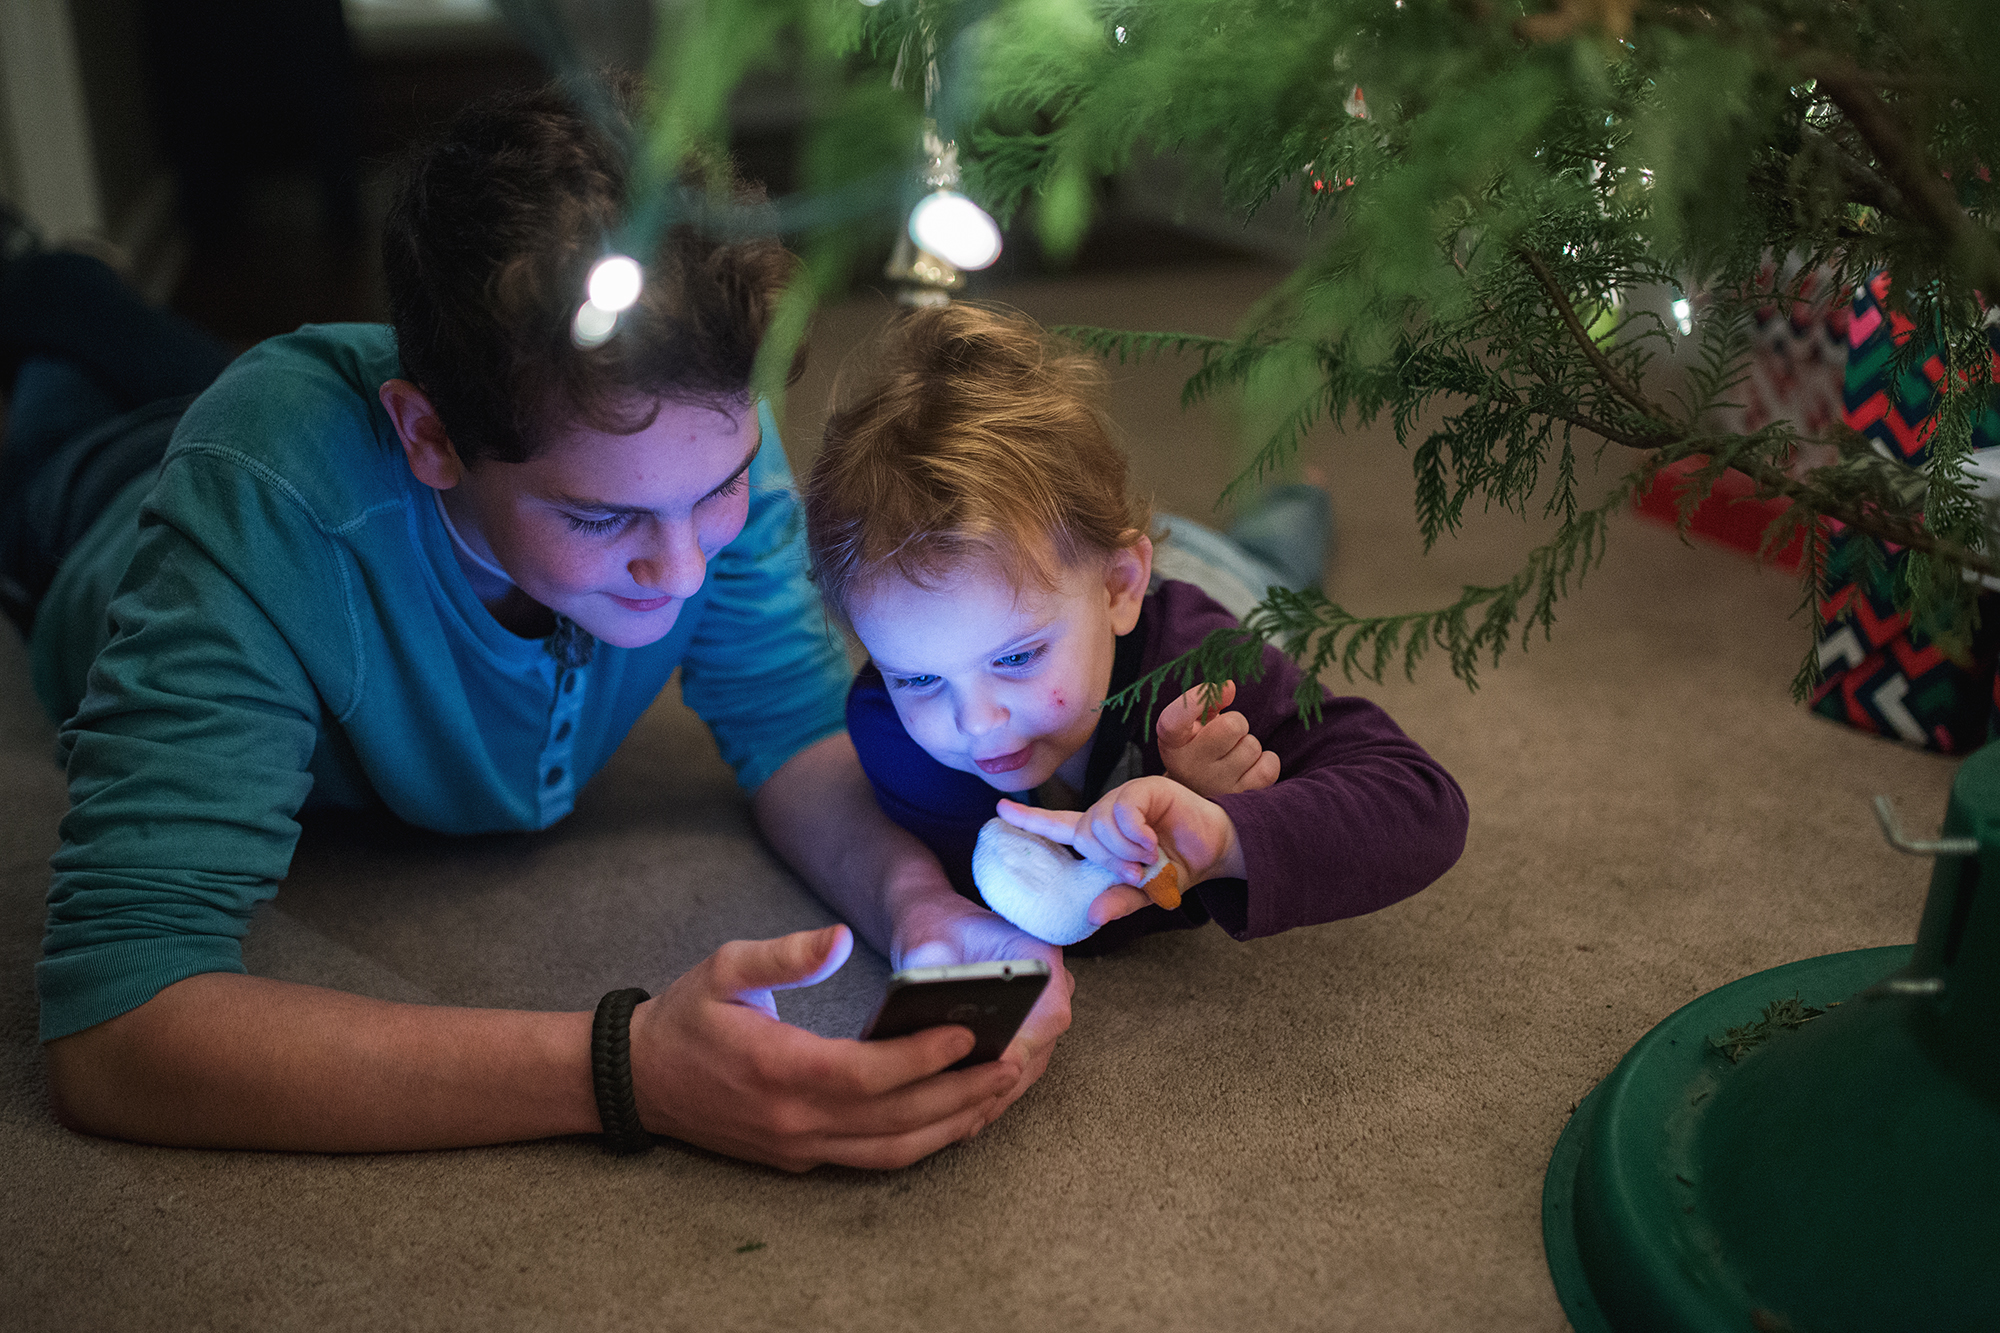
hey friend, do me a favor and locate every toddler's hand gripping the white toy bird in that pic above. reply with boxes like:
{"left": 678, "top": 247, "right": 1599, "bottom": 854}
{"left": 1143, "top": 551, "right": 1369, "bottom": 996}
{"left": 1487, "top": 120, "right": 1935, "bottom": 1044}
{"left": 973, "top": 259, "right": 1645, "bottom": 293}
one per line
{"left": 998, "top": 777, "right": 1244, "bottom": 925}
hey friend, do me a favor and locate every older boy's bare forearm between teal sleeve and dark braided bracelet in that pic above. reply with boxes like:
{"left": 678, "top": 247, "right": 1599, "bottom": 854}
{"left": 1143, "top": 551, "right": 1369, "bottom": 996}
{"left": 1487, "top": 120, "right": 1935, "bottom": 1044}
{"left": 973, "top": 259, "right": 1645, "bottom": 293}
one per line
{"left": 46, "top": 973, "right": 598, "bottom": 1153}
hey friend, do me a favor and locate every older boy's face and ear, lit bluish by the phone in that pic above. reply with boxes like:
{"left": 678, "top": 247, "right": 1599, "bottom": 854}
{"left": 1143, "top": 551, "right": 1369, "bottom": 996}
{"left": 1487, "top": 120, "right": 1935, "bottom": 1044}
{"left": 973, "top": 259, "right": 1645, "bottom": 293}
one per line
{"left": 444, "top": 402, "right": 760, "bottom": 648}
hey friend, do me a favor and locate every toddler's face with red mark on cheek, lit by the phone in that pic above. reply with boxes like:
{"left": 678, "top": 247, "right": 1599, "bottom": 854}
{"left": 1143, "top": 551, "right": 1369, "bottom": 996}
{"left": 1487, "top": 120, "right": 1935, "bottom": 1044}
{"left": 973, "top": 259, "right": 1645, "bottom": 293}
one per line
{"left": 850, "top": 538, "right": 1152, "bottom": 793}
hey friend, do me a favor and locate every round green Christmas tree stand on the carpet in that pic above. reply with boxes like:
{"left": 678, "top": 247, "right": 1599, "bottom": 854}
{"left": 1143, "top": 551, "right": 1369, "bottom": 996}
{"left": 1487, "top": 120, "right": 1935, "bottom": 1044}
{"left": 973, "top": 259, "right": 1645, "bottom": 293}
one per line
{"left": 1542, "top": 743, "right": 2000, "bottom": 1333}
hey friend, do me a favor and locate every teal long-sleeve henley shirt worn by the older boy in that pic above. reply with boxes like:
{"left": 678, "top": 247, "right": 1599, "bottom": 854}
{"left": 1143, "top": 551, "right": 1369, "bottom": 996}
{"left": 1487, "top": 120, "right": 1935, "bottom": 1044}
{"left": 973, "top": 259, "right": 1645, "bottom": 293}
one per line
{"left": 30, "top": 324, "right": 848, "bottom": 1041}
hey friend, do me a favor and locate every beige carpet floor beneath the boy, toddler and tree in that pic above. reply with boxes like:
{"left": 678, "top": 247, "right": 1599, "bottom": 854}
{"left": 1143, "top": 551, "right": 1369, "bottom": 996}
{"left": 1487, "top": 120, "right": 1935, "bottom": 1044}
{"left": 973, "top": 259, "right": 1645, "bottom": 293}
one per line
{"left": 0, "top": 268, "right": 1952, "bottom": 1333}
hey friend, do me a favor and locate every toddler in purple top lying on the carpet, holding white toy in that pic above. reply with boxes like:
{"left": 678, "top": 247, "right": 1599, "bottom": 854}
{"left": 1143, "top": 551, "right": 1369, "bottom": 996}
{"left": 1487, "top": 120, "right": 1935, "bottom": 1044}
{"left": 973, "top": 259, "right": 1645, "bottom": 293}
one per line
{"left": 806, "top": 304, "right": 1466, "bottom": 953}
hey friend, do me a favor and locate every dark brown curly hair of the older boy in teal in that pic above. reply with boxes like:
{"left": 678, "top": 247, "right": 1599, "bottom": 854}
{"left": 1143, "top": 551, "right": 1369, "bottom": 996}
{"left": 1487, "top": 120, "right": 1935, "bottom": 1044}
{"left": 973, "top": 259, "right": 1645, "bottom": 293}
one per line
{"left": 382, "top": 76, "right": 798, "bottom": 462}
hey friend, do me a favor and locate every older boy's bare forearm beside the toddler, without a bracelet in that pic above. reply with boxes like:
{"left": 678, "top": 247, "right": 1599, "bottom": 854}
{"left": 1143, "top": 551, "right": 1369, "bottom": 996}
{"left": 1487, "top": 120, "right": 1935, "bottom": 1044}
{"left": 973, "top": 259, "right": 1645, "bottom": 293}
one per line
{"left": 756, "top": 733, "right": 968, "bottom": 959}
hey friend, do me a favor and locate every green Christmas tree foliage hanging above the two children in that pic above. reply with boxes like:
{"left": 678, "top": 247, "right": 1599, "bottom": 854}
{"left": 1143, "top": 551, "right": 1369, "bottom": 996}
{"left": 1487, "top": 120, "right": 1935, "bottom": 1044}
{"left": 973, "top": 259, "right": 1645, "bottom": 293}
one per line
{"left": 556, "top": 0, "right": 2000, "bottom": 711}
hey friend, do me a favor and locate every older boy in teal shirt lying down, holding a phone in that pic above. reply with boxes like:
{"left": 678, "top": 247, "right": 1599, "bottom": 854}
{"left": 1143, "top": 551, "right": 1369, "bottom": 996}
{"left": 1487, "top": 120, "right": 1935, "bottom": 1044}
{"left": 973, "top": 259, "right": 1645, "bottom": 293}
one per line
{"left": 8, "top": 80, "right": 1068, "bottom": 1169}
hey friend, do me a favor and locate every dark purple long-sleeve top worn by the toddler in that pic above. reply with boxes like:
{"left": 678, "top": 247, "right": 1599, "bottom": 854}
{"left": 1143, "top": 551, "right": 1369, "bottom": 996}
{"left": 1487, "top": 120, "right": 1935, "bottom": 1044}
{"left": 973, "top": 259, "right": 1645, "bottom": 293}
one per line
{"left": 848, "top": 580, "right": 1466, "bottom": 953}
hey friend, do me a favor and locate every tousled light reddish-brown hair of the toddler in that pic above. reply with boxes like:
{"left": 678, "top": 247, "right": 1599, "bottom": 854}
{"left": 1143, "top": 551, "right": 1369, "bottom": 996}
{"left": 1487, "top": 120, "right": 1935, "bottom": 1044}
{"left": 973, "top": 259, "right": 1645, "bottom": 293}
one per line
{"left": 804, "top": 302, "right": 1150, "bottom": 620}
